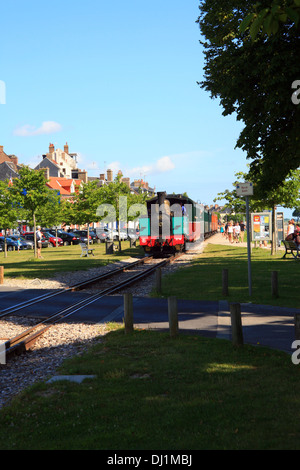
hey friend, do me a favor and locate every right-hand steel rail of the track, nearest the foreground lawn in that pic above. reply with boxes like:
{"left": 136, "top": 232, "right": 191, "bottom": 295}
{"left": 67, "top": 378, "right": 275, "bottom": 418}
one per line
{"left": 5, "top": 259, "right": 170, "bottom": 357}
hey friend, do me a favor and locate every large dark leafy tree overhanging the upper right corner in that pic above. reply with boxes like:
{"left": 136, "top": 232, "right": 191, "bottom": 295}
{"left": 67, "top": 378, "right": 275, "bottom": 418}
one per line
{"left": 198, "top": 0, "right": 300, "bottom": 194}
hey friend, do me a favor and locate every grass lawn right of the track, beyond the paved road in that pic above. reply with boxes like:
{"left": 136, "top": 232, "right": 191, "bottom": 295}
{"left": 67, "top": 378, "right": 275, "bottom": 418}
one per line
{"left": 153, "top": 244, "right": 300, "bottom": 308}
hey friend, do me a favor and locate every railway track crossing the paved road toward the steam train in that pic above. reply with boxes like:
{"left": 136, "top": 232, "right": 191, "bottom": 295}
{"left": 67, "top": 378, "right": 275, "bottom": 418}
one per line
{"left": 0, "top": 255, "right": 180, "bottom": 358}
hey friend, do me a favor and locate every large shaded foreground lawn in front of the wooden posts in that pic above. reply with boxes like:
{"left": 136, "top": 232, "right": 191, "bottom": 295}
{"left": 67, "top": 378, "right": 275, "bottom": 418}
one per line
{"left": 0, "top": 328, "right": 300, "bottom": 451}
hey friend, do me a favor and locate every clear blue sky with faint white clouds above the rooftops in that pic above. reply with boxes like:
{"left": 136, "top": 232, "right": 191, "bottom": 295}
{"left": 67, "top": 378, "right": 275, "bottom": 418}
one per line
{"left": 0, "top": 0, "right": 260, "bottom": 209}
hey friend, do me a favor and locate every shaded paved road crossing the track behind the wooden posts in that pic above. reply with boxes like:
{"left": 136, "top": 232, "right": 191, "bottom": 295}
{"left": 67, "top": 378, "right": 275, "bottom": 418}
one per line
{"left": 0, "top": 286, "right": 300, "bottom": 353}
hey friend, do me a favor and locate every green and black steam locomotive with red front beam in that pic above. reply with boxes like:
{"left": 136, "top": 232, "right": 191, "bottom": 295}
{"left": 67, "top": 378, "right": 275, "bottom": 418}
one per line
{"left": 139, "top": 192, "right": 218, "bottom": 255}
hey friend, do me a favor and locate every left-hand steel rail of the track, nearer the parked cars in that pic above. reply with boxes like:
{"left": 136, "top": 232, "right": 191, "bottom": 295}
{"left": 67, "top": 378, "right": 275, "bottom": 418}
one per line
{"left": 0, "top": 257, "right": 152, "bottom": 318}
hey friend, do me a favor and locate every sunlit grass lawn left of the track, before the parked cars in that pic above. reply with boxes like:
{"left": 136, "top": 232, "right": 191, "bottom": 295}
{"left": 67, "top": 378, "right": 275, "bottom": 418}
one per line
{"left": 0, "top": 241, "right": 143, "bottom": 279}
